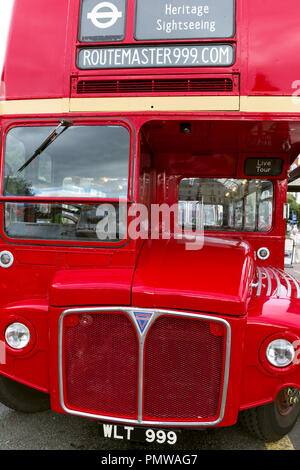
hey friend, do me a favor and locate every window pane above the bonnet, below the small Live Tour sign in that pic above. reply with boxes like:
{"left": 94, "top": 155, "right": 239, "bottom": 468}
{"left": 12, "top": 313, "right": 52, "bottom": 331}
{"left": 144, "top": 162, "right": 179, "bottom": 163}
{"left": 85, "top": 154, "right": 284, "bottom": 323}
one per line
{"left": 178, "top": 178, "right": 273, "bottom": 232}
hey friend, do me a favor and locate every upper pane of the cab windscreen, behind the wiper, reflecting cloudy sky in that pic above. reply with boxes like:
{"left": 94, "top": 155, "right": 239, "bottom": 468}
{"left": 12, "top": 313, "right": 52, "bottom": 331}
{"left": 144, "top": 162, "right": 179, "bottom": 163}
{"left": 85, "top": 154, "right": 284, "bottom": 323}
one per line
{"left": 4, "top": 125, "right": 130, "bottom": 199}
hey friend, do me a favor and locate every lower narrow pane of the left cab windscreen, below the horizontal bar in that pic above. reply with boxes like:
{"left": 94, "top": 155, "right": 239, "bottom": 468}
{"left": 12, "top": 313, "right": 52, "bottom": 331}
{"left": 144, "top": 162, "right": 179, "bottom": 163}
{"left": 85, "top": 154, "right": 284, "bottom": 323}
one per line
{"left": 4, "top": 202, "right": 127, "bottom": 242}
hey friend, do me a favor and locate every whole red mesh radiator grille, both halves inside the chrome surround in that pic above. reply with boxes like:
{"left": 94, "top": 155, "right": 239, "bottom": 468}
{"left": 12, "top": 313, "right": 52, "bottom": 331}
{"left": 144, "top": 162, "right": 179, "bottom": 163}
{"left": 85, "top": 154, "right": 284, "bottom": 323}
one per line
{"left": 61, "top": 309, "right": 227, "bottom": 425}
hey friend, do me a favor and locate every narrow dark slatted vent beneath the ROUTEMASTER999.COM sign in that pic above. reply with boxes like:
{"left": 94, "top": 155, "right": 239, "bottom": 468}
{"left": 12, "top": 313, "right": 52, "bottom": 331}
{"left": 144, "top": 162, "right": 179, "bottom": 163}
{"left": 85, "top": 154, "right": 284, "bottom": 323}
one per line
{"left": 76, "top": 78, "right": 233, "bottom": 95}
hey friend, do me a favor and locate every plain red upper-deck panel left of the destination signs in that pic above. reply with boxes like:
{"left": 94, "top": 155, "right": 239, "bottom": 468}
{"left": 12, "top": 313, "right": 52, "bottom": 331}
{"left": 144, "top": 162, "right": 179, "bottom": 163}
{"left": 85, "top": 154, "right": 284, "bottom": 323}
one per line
{"left": 4, "top": 0, "right": 69, "bottom": 99}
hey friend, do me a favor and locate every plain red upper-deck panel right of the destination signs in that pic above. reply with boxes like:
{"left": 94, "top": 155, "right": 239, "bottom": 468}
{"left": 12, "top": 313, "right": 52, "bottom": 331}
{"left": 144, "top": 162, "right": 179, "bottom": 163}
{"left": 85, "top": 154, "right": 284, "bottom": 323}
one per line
{"left": 240, "top": 0, "right": 300, "bottom": 95}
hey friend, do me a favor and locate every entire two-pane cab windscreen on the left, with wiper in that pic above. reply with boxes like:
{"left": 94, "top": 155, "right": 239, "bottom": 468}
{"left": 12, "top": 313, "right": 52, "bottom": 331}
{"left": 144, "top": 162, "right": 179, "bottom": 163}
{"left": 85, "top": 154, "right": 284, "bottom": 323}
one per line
{"left": 3, "top": 125, "right": 130, "bottom": 241}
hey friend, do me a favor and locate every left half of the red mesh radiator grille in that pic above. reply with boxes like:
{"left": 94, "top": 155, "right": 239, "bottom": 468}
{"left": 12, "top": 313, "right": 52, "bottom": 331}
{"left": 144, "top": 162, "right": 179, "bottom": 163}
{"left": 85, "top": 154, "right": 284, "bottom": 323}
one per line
{"left": 64, "top": 313, "right": 138, "bottom": 416}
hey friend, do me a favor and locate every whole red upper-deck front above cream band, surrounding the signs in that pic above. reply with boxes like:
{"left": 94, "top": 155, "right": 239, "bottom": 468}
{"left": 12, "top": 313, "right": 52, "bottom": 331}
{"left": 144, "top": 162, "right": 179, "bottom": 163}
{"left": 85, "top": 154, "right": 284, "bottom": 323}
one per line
{"left": 4, "top": 0, "right": 300, "bottom": 99}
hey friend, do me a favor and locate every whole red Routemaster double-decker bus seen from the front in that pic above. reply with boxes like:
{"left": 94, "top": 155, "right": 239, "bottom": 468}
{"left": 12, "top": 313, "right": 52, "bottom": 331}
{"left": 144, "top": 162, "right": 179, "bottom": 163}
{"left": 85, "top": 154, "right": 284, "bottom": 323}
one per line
{"left": 0, "top": 0, "right": 300, "bottom": 444}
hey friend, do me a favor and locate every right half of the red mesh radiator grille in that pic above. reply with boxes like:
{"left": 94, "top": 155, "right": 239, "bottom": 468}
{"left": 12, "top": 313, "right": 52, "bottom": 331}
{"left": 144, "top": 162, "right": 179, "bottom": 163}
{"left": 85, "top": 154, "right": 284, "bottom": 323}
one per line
{"left": 144, "top": 317, "right": 224, "bottom": 420}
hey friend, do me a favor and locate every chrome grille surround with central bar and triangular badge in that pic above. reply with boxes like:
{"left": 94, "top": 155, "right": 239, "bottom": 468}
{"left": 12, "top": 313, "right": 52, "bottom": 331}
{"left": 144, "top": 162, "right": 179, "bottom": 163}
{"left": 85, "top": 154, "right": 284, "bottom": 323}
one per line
{"left": 58, "top": 307, "right": 231, "bottom": 427}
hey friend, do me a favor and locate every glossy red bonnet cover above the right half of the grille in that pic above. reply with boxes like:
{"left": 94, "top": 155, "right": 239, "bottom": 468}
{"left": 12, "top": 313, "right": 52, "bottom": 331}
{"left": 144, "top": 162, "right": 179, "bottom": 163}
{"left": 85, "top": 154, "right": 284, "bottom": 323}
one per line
{"left": 132, "top": 237, "right": 253, "bottom": 315}
